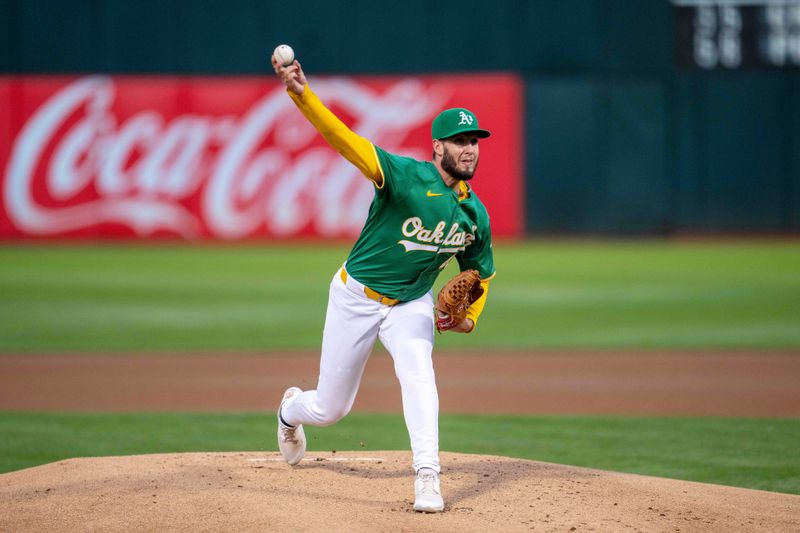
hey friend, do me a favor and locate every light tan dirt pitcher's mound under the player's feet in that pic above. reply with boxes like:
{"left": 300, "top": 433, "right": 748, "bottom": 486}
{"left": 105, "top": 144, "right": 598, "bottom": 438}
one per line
{"left": 0, "top": 452, "right": 800, "bottom": 532}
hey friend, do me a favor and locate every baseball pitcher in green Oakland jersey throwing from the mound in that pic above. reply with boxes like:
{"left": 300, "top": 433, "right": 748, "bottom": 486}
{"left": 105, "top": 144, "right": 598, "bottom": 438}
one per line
{"left": 272, "top": 50, "right": 495, "bottom": 512}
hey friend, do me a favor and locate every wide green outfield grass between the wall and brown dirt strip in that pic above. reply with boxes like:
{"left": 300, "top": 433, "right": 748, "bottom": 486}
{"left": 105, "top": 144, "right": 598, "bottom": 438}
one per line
{"left": 0, "top": 241, "right": 800, "bottom": 353}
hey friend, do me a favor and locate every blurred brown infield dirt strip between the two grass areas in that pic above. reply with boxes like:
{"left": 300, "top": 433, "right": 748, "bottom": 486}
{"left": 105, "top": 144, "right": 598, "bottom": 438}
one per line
{"left": 0, "top": 351, "right": 800, "bottom": 417}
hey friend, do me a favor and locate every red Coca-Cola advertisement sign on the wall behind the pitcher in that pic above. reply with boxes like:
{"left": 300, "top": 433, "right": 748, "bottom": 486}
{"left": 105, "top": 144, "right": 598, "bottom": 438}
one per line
{"left": 0, "top": 75, "right": 523, "bottom": 240}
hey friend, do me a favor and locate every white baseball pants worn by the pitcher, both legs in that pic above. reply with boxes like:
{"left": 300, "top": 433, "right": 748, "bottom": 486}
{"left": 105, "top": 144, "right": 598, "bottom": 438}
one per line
{"left": 282, "top": 271, "right": 439, "bottom": 472}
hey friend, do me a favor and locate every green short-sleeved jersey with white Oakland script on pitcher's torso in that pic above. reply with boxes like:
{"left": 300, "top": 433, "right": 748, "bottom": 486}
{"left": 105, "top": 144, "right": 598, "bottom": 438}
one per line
{"left": 346, "top": 146, "right": 494, "bottom": 301}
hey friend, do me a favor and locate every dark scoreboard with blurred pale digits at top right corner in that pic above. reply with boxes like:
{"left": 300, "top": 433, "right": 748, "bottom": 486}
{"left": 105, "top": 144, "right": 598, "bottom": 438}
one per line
{"left": 672, "top": 0, "right": 800, "bottom": 70}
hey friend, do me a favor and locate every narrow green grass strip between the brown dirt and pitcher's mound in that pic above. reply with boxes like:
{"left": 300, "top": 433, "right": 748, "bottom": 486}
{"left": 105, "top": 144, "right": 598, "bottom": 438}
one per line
{"left": 0, "top": 412, "right": 800, "bottom": 494}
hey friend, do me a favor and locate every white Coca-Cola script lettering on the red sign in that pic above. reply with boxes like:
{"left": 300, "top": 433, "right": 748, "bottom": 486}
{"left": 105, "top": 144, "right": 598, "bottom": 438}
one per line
{"left": 3, "top": 76, "right": 447, "bottom": 239}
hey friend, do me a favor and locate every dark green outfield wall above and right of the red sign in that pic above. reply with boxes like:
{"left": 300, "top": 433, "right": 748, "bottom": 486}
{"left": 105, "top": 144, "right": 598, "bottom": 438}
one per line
{"left": 0, "top": 0, "right": 800, "bottom": 234}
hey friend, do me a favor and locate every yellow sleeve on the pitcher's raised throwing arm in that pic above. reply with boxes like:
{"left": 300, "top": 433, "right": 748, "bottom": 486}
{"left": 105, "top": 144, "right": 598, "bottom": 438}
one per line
{"left": 286, "top": 84, "right": 383, "bottom": 187}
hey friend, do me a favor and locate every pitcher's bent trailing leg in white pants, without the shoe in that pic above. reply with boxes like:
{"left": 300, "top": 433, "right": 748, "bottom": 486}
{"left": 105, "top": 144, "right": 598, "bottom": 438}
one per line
{"left": 279, "top": 272, "right": 386, "bottom": 460}
